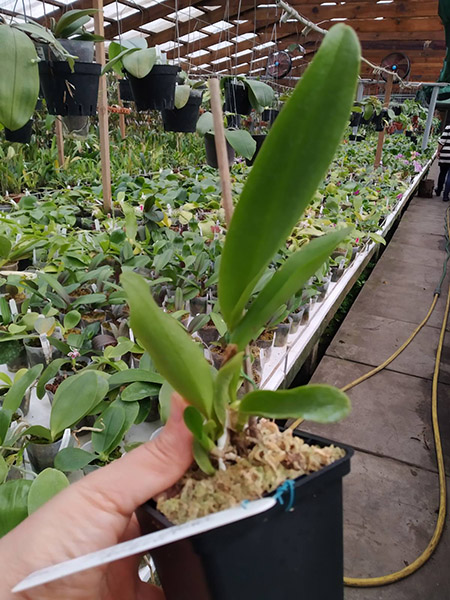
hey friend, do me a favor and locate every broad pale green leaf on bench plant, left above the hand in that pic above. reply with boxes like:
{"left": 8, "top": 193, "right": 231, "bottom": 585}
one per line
{"left": 50, "top": 371, "right": 109, "bottom": 439}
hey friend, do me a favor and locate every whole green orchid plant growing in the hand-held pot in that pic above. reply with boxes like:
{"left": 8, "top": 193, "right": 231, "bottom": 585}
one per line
{"left": 122, "top": 25, "right": 360, "bottom": 473}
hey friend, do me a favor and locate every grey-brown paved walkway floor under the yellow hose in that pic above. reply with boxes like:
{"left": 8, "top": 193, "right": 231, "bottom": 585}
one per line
{"left": 300, "top": 163, "right": 450, "bottom": 600}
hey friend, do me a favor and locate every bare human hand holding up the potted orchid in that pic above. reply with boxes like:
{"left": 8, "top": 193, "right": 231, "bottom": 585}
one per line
{"left": 0, "top": 394, "right": 192, "bottom": 600}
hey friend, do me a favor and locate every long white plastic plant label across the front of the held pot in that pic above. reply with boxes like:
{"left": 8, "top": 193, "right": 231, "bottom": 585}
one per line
{"left": 12, "top": 497, "right": 277, "bottom": 593}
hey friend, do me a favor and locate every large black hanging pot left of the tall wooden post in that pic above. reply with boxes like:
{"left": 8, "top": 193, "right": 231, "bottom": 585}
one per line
{"left": 39, "top": 61, "right": 101, "bottom": 117}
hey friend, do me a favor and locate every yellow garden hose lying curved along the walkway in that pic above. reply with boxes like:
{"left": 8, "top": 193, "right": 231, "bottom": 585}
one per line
{"left": 290, "top": 208, "right": 450, "bottom": 588}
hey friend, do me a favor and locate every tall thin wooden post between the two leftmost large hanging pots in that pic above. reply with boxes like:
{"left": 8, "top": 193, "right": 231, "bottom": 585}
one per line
{"left": 94, "top": 0, "right": 112, "bottom": 213}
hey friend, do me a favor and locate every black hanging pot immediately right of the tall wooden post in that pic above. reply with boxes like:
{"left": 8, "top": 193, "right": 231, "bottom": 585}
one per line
{"left": 127, "top": 65, "right": 180, "bottom": 110}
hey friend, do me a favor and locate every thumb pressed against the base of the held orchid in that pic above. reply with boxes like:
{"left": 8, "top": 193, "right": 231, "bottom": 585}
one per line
{"left": 75, "top": 393, "right": 192, "bottom": 515}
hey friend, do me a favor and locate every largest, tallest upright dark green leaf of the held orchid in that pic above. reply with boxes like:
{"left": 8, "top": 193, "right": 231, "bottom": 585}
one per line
{"left": 219, "top": 24, "right": 360, "bottom": 330}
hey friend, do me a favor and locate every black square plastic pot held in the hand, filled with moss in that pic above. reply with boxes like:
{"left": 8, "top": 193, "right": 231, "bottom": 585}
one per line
{"left": 137, "top": 433, "right": 353, "bottom": 600}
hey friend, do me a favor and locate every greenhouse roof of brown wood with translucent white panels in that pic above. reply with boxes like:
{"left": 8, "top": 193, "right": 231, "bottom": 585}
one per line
{"left": 0, "top": 0, "right": 445, "bottom": 81}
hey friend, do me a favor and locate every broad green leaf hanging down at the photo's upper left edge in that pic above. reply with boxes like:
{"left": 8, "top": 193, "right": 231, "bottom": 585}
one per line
{"left": 0, "top": 25, "right": 39, "bottom": 131}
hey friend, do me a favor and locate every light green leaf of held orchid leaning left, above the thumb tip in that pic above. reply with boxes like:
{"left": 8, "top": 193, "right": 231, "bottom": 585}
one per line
{"left": 121, "top": 271, "right": 213, "bottom": 417}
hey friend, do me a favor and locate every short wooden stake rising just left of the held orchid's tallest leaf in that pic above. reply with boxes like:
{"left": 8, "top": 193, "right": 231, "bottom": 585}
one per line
{"left": 209, "top": 79, "right": 233, "bottom": 226}
